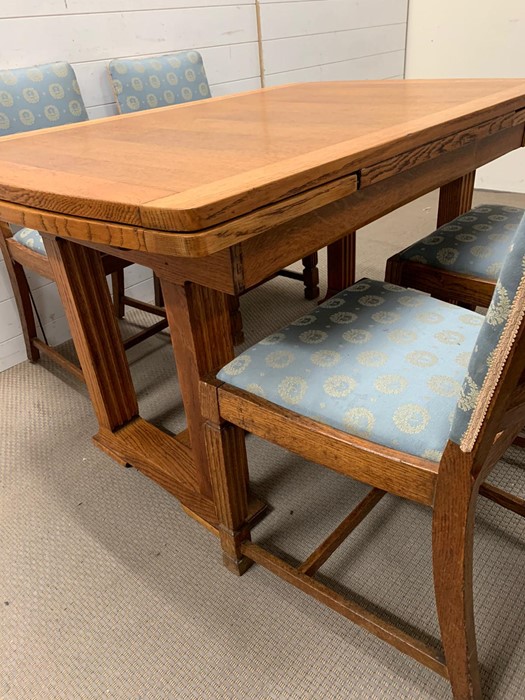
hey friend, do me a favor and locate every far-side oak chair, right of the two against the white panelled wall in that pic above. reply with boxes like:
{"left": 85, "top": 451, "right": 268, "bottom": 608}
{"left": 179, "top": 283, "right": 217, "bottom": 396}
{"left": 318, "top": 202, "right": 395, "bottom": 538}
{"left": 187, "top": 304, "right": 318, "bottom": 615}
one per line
{"left": 108, "top": 51, "right": 319, "bottom": 342}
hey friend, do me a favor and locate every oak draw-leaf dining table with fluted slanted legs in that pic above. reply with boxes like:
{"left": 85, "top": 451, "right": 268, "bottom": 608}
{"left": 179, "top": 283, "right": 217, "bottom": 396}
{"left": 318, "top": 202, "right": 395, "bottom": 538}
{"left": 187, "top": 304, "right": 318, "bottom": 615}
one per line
{"left": 0, "top": 79, "right": 525, "bottom": 529}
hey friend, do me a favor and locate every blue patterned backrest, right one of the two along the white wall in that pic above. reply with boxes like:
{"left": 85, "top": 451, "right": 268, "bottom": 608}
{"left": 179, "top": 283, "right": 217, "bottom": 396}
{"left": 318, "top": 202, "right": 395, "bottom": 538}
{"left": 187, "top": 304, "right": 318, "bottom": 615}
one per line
{"left": 108, "top": 51, "right": 210, "bottom": 114}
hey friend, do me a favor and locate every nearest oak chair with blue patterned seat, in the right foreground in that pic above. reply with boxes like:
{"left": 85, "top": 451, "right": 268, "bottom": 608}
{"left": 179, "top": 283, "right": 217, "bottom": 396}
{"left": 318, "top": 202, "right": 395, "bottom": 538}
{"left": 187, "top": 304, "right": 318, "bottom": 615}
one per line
{"left": 206, "top": 219, "right": 525, "bottom": 700}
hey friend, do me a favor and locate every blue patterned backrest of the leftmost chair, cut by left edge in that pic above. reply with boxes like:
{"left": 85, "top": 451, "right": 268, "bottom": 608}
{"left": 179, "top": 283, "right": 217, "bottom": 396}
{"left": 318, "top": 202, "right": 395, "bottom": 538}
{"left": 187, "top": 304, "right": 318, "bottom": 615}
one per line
{"left": 0, "top": 61, "right": 88, "bottom": 136}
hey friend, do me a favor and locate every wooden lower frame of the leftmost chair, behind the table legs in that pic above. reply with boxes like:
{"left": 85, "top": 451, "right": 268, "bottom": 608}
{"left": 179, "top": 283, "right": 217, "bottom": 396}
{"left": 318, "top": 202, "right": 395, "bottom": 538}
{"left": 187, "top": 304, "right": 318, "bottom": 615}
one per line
{"left": 0, "top": 221, "right": 168, "bottom": 381}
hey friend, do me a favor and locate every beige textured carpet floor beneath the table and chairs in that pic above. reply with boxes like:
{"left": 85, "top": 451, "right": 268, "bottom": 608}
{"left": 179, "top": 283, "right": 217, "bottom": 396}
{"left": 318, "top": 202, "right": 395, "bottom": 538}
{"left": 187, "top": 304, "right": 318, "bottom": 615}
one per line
{"left": 0, "top": 193, "right": 525, "bottom": 700}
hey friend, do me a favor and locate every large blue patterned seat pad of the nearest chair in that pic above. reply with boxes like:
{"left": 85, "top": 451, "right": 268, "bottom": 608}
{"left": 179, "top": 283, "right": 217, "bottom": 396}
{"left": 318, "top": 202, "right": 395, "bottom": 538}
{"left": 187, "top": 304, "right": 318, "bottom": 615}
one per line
{"left": 218, "top": 279, "right": 483, "bottom": 461}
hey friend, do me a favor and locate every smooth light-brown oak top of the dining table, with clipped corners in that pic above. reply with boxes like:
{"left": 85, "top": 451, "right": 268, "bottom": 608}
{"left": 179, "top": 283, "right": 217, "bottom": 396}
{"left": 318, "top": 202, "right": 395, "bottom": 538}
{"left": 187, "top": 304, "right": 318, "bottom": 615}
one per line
{"left": 0, "top": 79, "right": 525, "bottom": 235}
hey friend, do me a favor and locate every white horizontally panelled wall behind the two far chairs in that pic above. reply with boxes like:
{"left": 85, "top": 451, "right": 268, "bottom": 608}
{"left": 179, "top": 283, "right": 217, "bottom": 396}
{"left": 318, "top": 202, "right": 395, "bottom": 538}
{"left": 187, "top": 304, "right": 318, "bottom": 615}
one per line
{"left": 0, "top": 0, "right": 408, "bottom": 371}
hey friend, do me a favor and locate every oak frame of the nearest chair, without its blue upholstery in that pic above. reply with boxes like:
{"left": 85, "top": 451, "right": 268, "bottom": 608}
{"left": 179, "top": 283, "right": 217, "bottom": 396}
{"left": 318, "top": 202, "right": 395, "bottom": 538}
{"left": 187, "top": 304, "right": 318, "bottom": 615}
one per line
{"left": 202, "top": 306, "right": 525, "bottom": 700}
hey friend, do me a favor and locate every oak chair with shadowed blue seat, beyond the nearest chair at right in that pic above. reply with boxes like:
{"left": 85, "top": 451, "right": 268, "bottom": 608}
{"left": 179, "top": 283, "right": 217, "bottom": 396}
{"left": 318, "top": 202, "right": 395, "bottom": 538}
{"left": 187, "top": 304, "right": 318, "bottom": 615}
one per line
{"left": 385, "top": 204, "right": 525, "bottom": 308}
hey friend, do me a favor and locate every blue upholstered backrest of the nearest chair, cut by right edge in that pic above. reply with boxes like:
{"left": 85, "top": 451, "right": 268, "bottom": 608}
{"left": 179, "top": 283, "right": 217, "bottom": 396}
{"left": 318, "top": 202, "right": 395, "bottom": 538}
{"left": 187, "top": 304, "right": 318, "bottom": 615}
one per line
{"left": 450, "top": 217, "right": 525, "bottom": 452}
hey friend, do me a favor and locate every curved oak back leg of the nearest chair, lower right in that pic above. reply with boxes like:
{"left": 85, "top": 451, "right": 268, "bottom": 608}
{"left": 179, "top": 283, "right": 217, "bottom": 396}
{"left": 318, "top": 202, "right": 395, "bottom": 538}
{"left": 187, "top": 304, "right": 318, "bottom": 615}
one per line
{"left": 432, "top": 448, "right": 481, "bottom": 700}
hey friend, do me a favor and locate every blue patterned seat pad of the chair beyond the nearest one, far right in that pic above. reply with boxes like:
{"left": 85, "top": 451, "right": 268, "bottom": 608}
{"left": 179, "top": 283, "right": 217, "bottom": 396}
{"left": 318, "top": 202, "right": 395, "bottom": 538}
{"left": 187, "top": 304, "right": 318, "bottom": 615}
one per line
{"left": 399, "top": 204, "right": 525, "bottom": 282}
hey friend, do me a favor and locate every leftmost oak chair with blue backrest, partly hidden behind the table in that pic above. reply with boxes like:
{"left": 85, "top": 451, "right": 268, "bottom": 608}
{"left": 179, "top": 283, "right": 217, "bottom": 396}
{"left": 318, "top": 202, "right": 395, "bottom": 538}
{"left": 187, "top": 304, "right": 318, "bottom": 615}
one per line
{"left": 0, "top": 62, "right": 167, "bottom": 379}
